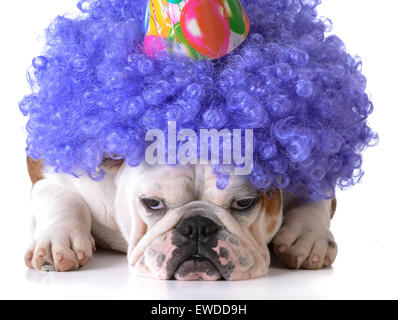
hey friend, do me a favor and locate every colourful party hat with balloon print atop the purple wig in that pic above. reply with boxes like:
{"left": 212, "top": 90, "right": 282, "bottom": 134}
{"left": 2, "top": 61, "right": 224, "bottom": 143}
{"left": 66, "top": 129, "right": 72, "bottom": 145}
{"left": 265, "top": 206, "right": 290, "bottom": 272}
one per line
{"left": 143, "top": 0, "right": 250, "bottom": 59}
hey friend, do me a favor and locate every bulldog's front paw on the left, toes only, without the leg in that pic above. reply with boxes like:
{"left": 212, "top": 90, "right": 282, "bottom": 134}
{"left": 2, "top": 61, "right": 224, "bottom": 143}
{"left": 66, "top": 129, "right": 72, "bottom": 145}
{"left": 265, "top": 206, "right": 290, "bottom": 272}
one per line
{"left": 25, "top": 228, "right": 95, "bottom": 271}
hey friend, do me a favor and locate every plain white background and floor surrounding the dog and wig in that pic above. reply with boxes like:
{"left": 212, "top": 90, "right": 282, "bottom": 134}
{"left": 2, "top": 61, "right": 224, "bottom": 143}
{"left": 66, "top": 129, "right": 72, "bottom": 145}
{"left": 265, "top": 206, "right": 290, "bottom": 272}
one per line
{"left": 0, "top": 0, "right": 398, "bottom": 299}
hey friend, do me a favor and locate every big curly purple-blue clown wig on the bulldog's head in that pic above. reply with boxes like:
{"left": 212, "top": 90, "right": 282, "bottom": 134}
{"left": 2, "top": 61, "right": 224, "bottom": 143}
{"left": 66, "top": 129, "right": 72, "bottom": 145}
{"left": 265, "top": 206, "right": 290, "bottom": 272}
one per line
{"left": 20, "top": 0, "right": 377, "bottom": 200}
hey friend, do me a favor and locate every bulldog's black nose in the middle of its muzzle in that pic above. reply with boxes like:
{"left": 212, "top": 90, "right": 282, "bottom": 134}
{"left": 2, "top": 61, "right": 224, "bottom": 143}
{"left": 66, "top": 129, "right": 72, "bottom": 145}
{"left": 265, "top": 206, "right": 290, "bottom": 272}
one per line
{"left": 176, "top": 216, "right": 220, "bottom": 241}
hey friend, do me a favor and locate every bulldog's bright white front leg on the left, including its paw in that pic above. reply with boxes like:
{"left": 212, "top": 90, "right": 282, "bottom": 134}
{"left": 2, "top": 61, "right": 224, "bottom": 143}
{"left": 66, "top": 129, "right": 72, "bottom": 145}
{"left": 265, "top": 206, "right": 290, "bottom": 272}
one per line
{"left": 25, "top": 179, "right": 94, "bottom": 271}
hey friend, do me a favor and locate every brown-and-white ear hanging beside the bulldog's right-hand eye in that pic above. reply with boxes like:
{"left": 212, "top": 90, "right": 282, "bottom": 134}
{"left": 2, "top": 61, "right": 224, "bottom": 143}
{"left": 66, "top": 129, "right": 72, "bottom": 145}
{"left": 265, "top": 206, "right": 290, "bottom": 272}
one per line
{"left": 250, "top": 188, "right": 283, "bottom": 245}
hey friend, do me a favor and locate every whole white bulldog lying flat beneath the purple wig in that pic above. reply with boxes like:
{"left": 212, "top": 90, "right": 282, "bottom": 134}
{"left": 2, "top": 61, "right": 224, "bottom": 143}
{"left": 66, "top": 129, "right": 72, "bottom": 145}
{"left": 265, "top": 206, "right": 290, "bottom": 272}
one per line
{"left": 25, "top": 158, "right": 337, "bottom": 280}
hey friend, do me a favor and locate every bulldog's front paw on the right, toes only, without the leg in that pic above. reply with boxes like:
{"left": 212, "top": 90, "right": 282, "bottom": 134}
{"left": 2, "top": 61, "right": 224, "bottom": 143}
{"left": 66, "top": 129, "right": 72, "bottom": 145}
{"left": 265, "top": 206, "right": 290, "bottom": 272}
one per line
{"left": 273, "top": 225, "right": 337, "bottom": 270}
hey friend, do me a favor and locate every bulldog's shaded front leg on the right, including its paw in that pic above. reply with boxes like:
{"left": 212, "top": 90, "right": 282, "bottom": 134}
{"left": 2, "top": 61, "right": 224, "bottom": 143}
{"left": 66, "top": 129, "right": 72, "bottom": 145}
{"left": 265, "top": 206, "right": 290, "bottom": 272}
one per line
{"left": 273, "top": 199, "right": 337, "bottom": 270}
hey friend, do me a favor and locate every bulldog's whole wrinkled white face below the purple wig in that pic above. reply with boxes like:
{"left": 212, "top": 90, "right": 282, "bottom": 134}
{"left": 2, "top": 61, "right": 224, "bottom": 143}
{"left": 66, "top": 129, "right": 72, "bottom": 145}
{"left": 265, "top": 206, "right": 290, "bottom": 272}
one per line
{"left": 115, "top": 165, "right": 282, "bottom": 280}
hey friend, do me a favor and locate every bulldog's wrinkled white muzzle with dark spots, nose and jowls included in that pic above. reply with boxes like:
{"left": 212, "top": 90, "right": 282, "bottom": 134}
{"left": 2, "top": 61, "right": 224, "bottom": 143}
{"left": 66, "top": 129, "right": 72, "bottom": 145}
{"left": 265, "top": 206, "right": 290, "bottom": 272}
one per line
{"left": 133, "top": 201, "right": 268, "bottom": 280}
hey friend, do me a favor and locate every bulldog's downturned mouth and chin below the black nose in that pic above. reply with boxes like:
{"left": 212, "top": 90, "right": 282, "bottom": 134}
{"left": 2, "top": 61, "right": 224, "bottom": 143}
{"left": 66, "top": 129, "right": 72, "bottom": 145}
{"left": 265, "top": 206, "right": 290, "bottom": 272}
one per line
{"left": 174, "top": 254, "right": 223, "bottom": 281}
